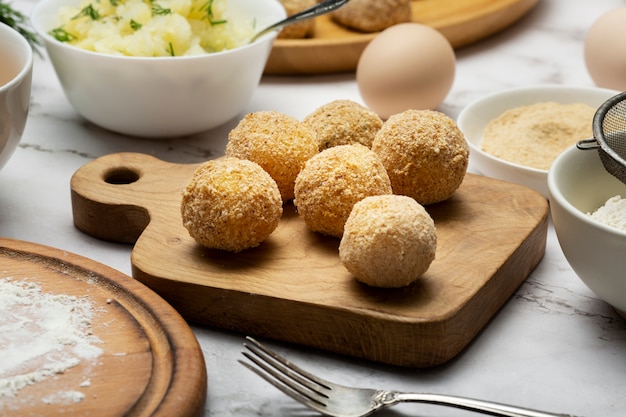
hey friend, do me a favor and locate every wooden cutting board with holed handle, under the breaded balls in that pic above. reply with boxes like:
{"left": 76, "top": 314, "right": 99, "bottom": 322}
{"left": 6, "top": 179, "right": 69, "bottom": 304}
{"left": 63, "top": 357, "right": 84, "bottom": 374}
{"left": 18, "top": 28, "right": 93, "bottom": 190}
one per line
{"left": 71, "top": 153, "right": 548, "bottom": 367}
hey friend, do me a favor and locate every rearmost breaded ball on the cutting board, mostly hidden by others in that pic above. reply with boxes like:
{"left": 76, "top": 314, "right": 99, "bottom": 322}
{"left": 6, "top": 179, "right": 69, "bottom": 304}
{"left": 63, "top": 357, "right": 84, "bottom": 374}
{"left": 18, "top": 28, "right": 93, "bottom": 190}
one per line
{"left": 303, "top": 100, "right": 383, "bottom": 151}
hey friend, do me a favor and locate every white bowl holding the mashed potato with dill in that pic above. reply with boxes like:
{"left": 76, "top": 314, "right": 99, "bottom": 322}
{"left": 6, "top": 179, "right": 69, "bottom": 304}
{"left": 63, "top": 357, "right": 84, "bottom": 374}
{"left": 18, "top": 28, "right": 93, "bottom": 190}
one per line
{"left": 31, "top": 0, "right": 286, "bottom": 137}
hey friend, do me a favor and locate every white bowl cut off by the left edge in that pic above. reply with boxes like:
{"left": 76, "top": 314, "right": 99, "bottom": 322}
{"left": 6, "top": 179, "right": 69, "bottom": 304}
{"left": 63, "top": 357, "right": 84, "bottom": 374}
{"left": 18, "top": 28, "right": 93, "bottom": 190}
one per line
{"left": 0, "top": 23, "right": 33, "bottom": 168}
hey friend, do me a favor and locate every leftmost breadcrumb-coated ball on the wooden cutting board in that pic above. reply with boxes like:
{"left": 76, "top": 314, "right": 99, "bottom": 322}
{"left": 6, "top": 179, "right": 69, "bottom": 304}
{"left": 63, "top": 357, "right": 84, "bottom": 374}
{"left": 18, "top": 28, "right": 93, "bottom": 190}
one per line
{"left": 181, "top": 157, "right": 283, "bottom": 252}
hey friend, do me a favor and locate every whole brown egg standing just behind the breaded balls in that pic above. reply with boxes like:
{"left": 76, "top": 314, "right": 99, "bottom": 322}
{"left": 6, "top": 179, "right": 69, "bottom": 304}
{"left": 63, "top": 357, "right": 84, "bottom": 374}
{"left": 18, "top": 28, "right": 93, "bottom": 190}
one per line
{"left": 356, "top": 23, "right": 456, "bottom": 119}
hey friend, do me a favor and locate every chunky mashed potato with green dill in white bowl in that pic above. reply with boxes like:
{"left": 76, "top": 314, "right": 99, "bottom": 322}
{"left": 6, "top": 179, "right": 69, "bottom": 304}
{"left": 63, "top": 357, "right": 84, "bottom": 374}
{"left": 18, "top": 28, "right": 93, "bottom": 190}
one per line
{"left": 51, "top": 0, "right": 254, "bottom": 57}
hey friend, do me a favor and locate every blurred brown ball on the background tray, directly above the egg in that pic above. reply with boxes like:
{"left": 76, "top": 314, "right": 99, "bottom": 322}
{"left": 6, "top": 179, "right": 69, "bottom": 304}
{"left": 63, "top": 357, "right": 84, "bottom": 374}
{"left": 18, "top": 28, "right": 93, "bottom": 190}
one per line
{"left": 331, "top": 0, "right": 411, "bottom": 32}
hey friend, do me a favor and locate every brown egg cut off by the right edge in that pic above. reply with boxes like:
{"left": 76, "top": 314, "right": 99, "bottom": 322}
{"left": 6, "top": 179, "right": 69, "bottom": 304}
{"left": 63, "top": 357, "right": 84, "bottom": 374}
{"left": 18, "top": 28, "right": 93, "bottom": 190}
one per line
{"left": 584, "top": 7, "right": 626, "bottom": 91}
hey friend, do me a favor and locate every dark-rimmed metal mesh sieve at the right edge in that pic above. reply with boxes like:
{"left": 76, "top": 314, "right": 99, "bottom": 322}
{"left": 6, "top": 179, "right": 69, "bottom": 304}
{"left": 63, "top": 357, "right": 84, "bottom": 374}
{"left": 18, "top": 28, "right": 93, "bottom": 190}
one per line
{"left": 576, "top": 92, "right": 626, "bottom": 184}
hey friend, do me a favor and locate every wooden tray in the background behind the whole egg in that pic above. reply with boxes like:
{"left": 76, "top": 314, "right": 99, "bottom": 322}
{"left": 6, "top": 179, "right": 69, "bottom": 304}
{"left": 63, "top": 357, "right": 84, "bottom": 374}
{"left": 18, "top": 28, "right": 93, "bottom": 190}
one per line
{"left": 265, "top": 0, "right": 539, "bottom": 75}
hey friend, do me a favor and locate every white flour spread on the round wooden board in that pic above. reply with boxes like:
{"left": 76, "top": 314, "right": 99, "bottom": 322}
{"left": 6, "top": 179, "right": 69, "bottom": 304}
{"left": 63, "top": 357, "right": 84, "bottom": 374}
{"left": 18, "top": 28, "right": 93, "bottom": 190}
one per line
{"left": 0, "top": 278, "right": 102, "bottom": 402}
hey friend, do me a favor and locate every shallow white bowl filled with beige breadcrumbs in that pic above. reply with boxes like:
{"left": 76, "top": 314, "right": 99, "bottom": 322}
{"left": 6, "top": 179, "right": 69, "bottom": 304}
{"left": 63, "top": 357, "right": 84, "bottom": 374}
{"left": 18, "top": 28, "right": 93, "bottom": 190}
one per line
{"left": 457, "top": 85, "right": 616, "bottom": 198}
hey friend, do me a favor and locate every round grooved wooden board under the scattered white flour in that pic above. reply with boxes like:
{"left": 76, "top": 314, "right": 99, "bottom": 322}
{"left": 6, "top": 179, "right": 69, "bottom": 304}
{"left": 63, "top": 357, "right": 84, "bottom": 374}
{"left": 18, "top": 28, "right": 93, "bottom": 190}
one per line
{"left": 0, "top": 239, "right": 207, "bottom": 417}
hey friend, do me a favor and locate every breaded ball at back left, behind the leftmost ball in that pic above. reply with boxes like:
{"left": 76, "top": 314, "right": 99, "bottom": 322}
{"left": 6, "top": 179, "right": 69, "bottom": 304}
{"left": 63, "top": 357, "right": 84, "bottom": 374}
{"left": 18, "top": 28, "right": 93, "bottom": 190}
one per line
{"left": 226, "top": 111, "right": 318, "bottom": 201}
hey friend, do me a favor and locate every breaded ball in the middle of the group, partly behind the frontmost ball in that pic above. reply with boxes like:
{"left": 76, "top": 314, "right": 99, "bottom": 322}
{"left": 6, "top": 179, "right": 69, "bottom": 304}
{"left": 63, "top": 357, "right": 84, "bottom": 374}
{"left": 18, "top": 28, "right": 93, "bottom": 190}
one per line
{"left": 294, "top": 144, "right": 392, "bottom": 237}
